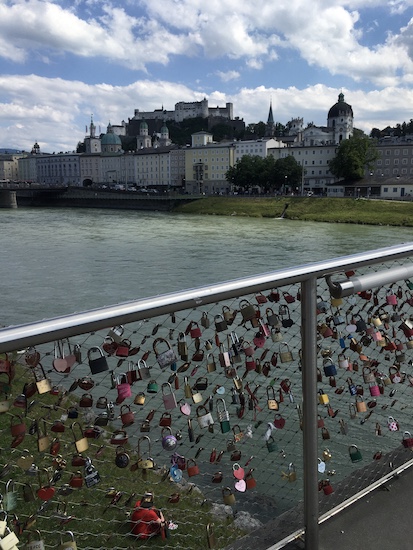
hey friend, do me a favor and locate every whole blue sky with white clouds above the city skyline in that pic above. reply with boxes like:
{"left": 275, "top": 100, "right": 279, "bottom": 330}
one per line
{"left": 0, "top": 0, "right": 413, "bottom": 153}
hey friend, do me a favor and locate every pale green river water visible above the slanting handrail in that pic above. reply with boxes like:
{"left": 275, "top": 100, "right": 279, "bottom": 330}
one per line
{"left": 0, "top": 208, "right": 413, "bottom": 326}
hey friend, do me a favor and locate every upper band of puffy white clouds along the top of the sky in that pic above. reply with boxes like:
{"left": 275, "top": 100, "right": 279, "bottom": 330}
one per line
{"left": 0, "top": 0, "right": 412, "bottom": 86}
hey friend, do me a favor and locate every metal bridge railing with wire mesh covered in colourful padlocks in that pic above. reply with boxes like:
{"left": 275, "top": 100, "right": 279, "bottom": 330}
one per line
{"left": 0, "top": 243, "right": 413, "bottom": 550}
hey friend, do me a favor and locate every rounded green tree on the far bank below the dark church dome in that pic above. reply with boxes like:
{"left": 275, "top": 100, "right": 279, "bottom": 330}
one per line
{"left": 329, "top": 134, "right": 378, "bottom": 181}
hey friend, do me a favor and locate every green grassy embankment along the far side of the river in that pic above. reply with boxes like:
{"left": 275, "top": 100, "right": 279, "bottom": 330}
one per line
{"left": 175, "top": 197, "right": 413, "bottom": 227}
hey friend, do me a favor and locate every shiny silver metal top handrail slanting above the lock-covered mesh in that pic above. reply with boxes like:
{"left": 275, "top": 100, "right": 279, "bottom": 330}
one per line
{"left": 0, "top": 242, "right": 413, "bottom": 353}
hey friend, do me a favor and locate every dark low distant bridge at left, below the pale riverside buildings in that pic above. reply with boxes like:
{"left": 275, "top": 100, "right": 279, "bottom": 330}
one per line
{"left": 0, "top": 187, "right": 202, "bottom": 212}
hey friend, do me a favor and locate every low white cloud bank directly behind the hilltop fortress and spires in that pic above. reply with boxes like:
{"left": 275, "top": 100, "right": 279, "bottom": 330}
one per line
{"left": 4, "top": 75, "right": 413, "bottom": 152}
